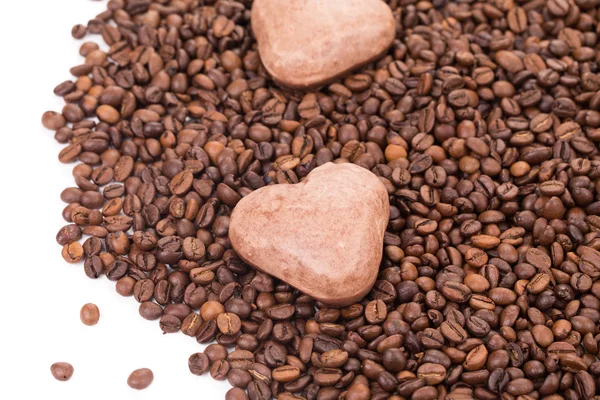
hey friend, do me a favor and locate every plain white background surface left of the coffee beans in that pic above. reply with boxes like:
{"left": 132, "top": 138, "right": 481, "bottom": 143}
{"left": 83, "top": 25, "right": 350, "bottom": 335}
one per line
{"left": 0, "top": 0, "right": 229, "bottom": 400}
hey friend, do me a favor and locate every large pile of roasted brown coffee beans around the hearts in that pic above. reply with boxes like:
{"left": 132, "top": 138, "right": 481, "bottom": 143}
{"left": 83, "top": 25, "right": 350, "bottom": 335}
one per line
{"left": 42, "top": 0, "right": 600, "bottom": 400}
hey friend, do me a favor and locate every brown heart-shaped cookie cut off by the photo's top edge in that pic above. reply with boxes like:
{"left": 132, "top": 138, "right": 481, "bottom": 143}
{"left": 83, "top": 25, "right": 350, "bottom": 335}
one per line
{"left": 252, "top": 0, "right": 396, "bottom": 89}
